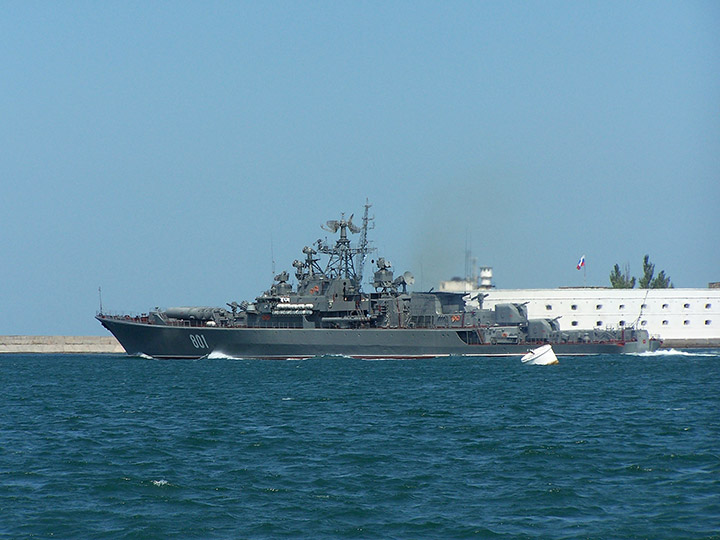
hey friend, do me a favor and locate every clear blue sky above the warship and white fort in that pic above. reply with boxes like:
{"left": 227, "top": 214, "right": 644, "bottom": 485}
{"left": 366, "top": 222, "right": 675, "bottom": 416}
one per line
{"left": 0, "top": 0, "right": 720, "bottom": 335}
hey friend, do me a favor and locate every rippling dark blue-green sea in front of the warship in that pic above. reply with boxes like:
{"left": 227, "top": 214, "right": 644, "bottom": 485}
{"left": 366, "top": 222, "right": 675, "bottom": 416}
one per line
{"left": 0, "top": 350, "right": 720, "bottom": 539}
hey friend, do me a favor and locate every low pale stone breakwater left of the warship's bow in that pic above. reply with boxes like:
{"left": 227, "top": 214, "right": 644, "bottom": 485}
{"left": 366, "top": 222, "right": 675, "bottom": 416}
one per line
{"left": 0, "top": 336, "right": 125, "bottom": 354}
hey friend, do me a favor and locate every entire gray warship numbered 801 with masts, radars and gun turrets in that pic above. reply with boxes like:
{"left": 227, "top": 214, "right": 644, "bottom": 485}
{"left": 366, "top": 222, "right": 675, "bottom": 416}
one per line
{"left": 96, "top": 203, "right": 660, "bottom": 359}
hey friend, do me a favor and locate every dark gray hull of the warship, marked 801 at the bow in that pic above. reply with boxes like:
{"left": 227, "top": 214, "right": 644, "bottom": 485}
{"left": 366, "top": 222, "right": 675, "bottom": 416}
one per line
{"left": 98, "top": 316, "right": 660, "bottom": 359}
